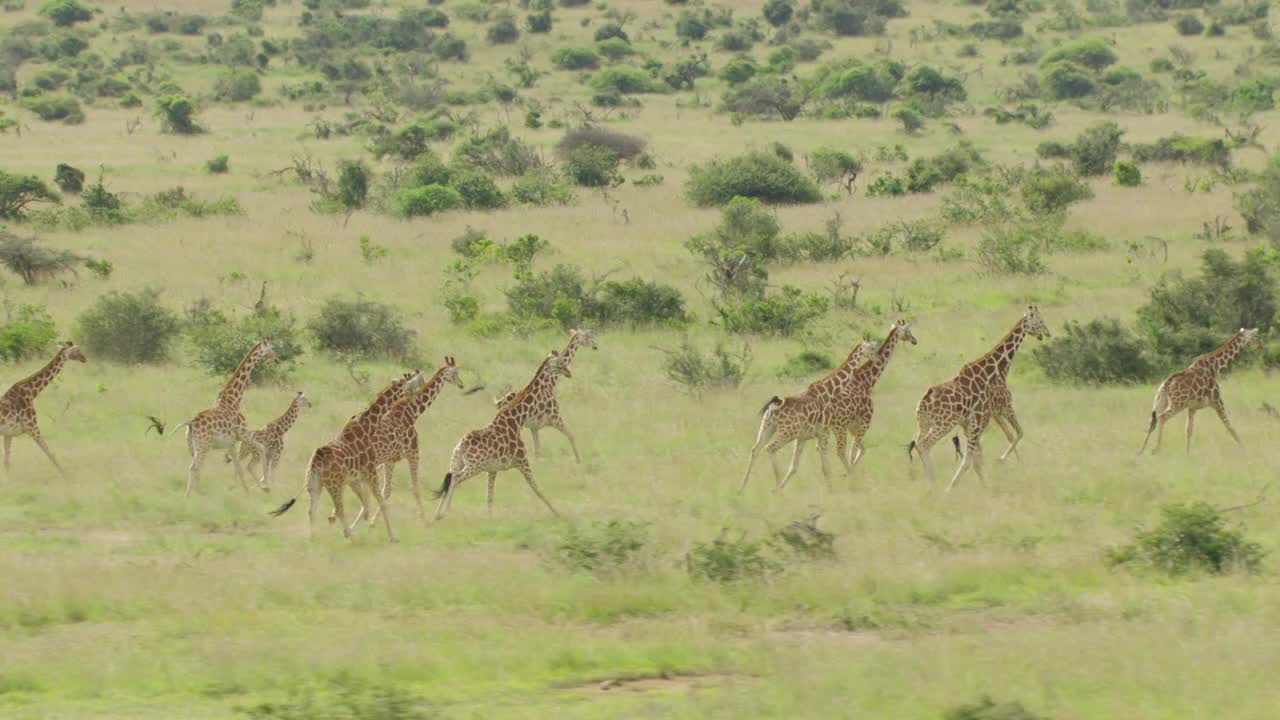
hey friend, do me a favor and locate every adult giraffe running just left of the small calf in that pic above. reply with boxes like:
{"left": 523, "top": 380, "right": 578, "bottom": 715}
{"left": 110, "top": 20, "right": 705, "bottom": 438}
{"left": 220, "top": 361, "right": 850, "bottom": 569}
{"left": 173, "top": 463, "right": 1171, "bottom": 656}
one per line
{"left": 174, "top": 340, "right": 275, "bottom": 496}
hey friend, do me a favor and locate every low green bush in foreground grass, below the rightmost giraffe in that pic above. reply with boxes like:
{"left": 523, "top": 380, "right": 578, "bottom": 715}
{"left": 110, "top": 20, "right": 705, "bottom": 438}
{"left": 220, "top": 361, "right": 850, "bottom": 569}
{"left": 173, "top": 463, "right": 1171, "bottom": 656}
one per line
{"left": 1107, "top": 502, "right": 1266, "bottom": 575}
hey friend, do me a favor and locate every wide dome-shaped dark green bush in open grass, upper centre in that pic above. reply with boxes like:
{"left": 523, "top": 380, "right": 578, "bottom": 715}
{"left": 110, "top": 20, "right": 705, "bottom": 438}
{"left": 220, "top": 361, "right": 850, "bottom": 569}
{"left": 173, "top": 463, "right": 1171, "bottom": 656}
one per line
{"left": 685, "top": 151, "right": 822, "bottom": 208}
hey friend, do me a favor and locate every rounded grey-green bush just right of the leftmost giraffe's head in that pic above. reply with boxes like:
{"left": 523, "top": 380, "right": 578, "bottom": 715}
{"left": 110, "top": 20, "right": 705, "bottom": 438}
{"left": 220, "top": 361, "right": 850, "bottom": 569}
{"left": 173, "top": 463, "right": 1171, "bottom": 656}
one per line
{"left": 76, "top": 288, "right": 182, "bottom": 364}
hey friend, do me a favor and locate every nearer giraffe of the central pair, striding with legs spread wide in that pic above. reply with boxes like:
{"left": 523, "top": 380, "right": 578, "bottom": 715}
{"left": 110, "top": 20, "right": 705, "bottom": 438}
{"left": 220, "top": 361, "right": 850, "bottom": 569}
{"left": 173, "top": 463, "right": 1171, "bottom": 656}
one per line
{"left": 435, "top": 350, "right": 572, "bottom": 520}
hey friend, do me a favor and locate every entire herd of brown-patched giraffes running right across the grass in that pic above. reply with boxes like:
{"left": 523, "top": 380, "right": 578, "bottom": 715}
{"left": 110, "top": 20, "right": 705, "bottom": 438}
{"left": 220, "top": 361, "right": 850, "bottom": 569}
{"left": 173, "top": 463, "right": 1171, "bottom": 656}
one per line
{"left": 0, "top": 311, "right": 1262, "bottom": 542}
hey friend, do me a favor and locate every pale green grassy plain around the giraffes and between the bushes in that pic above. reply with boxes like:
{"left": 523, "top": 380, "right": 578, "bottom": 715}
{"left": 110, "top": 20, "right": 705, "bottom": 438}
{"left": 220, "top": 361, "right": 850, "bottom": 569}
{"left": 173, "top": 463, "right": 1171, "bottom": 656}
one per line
{"left": 0, "top": 0, "right": 1280, "bottom": 720}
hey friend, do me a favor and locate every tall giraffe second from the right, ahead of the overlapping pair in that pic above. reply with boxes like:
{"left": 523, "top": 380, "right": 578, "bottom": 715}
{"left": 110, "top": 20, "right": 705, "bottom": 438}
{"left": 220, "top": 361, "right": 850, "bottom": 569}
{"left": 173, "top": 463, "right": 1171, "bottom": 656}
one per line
{"left": 906, "top": 305, "right": 1050, "bottom": 492}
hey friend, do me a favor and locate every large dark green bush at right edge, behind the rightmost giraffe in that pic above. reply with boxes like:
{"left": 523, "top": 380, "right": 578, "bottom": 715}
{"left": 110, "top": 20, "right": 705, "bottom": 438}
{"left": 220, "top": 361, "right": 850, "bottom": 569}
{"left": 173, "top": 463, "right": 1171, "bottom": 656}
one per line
{"left": 1138, "top": 247, "right": 1280, "bottom": 366}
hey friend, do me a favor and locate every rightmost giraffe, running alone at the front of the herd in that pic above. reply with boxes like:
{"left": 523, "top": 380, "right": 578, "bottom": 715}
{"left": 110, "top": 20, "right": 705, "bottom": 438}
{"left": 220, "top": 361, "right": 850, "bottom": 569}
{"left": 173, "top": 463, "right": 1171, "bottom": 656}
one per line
{"left": 1138, "top": 328, "right": 1262, "bottom": 455}
